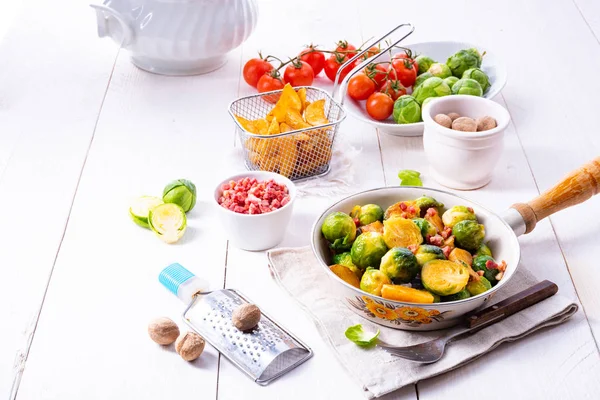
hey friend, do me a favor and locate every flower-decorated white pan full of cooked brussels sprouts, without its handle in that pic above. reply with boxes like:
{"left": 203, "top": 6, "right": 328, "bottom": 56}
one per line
{"left": 312, "top": 187, "right": 522, "bottom": 331}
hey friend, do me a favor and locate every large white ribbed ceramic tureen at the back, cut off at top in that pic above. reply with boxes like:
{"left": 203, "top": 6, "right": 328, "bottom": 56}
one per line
{"left": 91, "top": 0, "right": 257, "bottom": 75}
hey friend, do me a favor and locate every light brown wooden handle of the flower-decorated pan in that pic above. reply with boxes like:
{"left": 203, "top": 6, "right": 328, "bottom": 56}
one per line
{"left": 511, "top": 157, "right": 600, "bottom": 233}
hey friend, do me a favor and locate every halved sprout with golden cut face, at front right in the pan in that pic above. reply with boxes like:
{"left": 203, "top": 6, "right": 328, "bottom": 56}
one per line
{"left": 421, "top": 260, "right": 469, "bottom": 296}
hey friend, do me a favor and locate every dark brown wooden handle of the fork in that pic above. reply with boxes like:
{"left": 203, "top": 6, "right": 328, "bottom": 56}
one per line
{"left": 467, "top": 281, "right": 558, "bottom": 329}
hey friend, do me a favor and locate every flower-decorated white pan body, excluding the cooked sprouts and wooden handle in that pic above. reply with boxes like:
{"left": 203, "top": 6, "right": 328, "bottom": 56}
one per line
{"left": 311, "top": 186, "right": 523, "bottom": 331}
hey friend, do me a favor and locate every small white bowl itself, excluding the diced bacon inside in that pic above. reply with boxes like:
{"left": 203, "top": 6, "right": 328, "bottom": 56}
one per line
{"left": 214, "top": 171, "right": 296, "bottom": 251}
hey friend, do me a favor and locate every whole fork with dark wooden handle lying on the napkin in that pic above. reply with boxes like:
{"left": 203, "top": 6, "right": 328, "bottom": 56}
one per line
{"left": 377, "top": 281, "right": 558, "bottom": 364}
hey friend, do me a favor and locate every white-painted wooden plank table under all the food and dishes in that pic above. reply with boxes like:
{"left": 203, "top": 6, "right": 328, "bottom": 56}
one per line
{"left": 0, "top": 0, "right": 600, "bottom": 400}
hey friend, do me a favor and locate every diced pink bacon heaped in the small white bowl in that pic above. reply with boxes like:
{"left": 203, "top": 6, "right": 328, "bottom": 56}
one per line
{"left": 218, "top": 178, "right": 291, "bottom": 215}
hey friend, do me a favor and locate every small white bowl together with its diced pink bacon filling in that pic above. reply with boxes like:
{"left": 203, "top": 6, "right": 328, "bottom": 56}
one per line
{"left": 214, "top": 171, "right": 296, "bottom": 251}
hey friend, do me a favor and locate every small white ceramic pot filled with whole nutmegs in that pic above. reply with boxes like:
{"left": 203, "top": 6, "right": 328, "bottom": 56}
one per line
{"left": 423, "top": 95, "right": 510, "bottom": 190}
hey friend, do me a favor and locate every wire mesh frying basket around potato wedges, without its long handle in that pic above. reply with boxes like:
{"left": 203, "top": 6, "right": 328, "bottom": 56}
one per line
{"left": 229, "top": 86, "right": 346, "bottom": 181}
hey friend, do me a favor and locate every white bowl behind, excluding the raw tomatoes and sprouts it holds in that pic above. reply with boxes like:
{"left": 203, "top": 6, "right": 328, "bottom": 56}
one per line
{"left": 344, "top": 42, "right": 506, "bottom": 136}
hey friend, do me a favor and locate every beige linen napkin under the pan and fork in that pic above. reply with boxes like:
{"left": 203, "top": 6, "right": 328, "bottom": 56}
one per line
{"left": 267, "top": 247, "right": 578, "bottom": 398}
